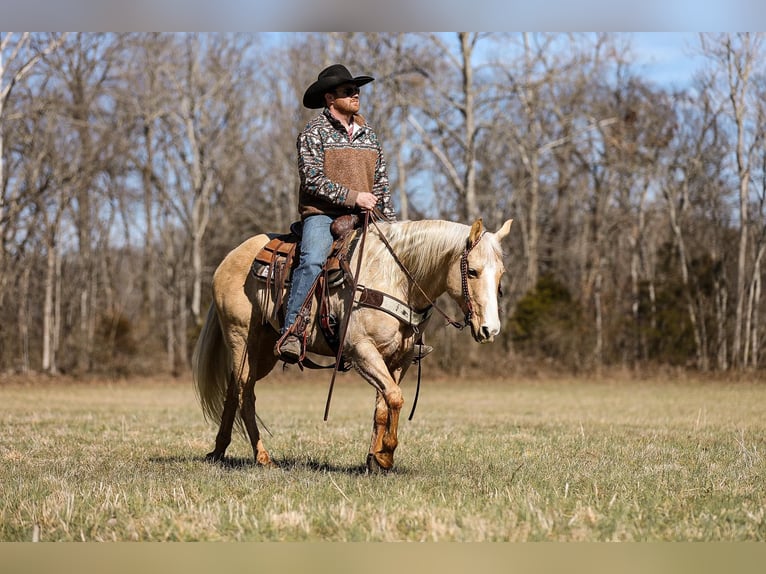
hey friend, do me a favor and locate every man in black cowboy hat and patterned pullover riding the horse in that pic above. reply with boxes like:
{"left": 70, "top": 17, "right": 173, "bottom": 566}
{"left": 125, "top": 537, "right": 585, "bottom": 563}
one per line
{"left": 274, "top": 64, "right": 396, "bottom": 363}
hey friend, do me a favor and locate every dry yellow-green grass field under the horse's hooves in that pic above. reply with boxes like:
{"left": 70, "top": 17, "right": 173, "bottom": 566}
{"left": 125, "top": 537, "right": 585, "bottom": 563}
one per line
{"left": 0, "top": 371, "right": 766, "bottom": 541}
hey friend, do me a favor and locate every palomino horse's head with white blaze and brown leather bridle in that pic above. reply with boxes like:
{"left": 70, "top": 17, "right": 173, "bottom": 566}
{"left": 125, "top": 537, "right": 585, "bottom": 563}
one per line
{"left": 447, "top": 219, "right": 513, "bottom": 343}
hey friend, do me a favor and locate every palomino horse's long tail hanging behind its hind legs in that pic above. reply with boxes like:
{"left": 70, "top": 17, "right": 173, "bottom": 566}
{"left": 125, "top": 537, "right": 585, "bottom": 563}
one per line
{"left": 192, "top": 305, "right": 231, "bottom": 423}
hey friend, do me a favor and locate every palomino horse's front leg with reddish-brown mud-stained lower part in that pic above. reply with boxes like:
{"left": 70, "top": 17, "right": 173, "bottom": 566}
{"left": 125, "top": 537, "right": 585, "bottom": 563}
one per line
{"left": 356, "top": 343, "right": 404, "bottom": 471}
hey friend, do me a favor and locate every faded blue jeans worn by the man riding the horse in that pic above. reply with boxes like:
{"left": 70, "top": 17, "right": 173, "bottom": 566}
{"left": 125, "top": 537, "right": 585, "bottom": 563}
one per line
{"left": 282, "top": 215, "right": 333, "bottom": 333}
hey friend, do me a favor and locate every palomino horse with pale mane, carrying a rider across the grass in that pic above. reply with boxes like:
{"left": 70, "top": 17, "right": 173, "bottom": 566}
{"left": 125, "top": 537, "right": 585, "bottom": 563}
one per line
{"left": 192, "top": 219, "right": 512, "bottom": 471}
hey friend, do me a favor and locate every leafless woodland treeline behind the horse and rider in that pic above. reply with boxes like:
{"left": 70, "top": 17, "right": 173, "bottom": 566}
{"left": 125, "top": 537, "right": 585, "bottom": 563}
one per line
{"left": 0, "top": 33, "right": 766, "bottom": 375}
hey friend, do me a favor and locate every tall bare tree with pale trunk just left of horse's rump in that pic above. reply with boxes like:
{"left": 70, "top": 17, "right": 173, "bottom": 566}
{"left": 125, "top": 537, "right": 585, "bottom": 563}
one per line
{"left": 147, "top": 34, "right": 258, "bottom": 336}
